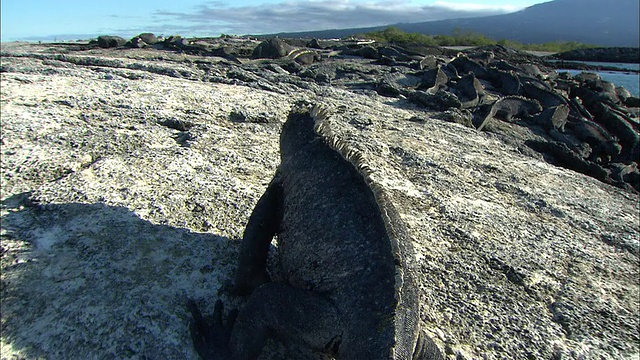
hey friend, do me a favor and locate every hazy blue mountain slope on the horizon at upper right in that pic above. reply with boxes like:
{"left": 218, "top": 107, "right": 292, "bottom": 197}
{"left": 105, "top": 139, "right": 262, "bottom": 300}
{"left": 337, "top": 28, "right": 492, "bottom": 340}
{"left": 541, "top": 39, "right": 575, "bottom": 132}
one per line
{"left": 278, "top": 0, "right": 640, "bottom": 47}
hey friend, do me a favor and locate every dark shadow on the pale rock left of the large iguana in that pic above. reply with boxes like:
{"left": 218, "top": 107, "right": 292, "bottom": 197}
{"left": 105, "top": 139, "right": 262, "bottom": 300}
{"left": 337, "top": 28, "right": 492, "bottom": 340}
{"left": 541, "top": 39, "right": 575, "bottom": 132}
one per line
{"left": 0, "top": 194, "right": 236, "bottom": 359}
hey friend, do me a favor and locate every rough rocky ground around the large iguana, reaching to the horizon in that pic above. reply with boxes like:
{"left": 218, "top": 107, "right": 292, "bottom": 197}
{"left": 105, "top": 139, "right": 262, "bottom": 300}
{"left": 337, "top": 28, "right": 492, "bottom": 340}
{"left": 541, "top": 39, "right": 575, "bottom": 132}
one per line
{"left": 0, "top": 37, "right": 640, "bottom": 359}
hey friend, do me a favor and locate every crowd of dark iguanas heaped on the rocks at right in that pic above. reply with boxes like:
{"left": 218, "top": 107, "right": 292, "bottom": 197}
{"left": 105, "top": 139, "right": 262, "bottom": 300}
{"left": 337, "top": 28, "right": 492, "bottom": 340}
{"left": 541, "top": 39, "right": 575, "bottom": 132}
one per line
{"left": 408, "top": 48, "right": 640, "bottom": 192}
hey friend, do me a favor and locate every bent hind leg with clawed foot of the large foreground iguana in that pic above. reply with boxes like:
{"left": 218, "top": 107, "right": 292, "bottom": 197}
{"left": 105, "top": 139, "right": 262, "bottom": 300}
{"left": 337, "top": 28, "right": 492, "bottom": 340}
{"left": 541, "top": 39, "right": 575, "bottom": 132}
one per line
{"left": 188, "top": 283, "right": 343, "bottom": 360}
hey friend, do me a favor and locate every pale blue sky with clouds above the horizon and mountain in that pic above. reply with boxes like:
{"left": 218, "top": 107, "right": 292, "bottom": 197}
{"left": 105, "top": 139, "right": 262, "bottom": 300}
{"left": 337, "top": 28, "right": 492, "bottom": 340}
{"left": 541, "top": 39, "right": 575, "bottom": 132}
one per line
{"left": 0, "top": 0, "right": 548, "bottom": 41}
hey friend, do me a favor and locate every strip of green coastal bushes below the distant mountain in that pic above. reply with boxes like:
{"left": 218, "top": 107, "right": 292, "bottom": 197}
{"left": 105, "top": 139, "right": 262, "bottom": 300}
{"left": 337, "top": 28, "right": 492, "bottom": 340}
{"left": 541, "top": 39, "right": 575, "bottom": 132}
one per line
{"left": 359, "top": 26, "right": 596, "bottom": 52}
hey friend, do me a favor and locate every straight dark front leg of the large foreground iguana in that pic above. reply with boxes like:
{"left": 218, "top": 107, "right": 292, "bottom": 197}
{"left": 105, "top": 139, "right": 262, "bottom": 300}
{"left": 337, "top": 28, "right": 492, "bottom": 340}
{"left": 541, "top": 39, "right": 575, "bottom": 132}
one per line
{"left": 232, "top": 171, "right": 282, "bottom": 295}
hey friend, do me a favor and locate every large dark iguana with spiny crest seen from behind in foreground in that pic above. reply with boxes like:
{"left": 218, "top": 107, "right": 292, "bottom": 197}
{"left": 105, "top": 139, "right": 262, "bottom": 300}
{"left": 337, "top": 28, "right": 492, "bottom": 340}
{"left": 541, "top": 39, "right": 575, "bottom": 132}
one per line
{"left": 189, "top": 106, "right": 442, "bottom": 360}
